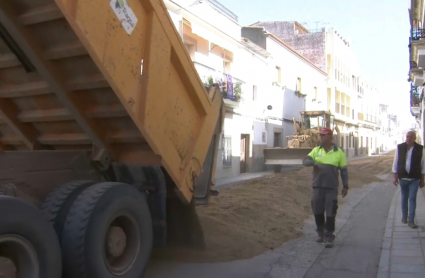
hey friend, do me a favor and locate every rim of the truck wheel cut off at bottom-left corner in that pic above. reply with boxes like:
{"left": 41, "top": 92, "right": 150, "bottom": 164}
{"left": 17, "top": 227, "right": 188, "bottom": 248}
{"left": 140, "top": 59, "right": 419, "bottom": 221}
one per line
{"left": 0, "top": 235, "right": 40, "bottom": 278}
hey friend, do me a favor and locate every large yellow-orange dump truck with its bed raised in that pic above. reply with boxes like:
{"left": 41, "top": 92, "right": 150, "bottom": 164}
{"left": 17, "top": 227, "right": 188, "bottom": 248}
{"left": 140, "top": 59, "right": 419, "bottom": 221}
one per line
{"left": 0, "top": 0, "right": 224, "bottom": 278}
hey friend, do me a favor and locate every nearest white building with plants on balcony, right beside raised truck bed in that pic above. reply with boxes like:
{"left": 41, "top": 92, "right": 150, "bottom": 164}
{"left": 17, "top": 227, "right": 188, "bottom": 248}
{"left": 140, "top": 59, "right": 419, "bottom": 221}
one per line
{"left": 165, "top": 0, "right": 274, "bottom": 178}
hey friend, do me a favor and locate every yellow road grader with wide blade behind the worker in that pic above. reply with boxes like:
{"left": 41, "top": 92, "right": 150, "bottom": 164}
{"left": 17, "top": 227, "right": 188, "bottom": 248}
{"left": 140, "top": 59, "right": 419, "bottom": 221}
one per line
{"left": 264, "top": 111, "right": 337, "bottom": 167}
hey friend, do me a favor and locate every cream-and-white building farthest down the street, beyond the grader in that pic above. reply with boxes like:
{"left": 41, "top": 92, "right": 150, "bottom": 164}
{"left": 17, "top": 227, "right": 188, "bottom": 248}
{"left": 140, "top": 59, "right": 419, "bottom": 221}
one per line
{"left": 251, "top": 21, "right": 380, "bottom": 157}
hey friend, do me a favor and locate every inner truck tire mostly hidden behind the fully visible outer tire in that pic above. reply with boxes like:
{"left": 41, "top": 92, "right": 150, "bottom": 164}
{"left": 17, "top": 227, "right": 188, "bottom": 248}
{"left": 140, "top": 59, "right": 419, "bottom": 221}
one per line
{"left": 40, "top": 181, "right": 96, "bottom": 242}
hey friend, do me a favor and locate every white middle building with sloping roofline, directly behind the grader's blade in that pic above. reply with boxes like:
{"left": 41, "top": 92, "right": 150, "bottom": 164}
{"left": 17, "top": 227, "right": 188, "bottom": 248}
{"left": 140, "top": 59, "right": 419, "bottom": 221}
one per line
{"left": 242, "top": 27, "right": 327, "bottom": 150}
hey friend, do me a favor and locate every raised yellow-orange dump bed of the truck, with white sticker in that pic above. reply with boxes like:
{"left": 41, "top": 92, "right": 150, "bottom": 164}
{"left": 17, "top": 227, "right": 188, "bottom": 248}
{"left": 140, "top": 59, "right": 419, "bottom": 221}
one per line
{"left": 0, "top": 0, "right": 222, "bottom": 202}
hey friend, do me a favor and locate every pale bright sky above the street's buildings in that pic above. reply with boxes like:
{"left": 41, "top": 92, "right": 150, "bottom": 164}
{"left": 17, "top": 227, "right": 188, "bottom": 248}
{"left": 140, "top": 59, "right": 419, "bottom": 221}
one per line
{"left": 218, "top": 0, "right": 414, "bottom": 127}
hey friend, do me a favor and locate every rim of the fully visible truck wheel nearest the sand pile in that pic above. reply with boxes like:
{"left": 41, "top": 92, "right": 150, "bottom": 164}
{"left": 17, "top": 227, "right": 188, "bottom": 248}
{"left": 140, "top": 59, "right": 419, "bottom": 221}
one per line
{"left": 103, "top": 212, "right": 140, "bottom": 275}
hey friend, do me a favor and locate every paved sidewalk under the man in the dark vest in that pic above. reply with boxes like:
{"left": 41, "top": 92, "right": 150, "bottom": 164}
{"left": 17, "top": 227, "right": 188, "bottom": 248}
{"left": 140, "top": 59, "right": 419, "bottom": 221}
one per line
{"left": 377, "top": 186, "right": 425, "bottom": 278}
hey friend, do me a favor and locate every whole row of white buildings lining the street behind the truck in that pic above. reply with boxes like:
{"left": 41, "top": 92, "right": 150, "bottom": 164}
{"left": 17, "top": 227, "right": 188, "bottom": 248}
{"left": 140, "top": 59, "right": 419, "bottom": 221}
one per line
{"left": 164, "top": 0, "right": 382, "bottom": 182}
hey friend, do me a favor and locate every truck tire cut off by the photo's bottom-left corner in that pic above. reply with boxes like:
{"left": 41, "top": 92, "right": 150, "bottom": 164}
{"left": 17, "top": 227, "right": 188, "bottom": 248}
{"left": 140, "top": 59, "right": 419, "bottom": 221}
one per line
{"left": 0, "top": 196, "right": 62, "bottom": 278}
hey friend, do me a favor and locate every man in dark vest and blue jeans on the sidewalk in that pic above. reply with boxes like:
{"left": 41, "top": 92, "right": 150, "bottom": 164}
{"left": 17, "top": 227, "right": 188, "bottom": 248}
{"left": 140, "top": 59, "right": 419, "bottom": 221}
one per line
{"left": 393, "top": 131, "right": 425, "bottom": 229}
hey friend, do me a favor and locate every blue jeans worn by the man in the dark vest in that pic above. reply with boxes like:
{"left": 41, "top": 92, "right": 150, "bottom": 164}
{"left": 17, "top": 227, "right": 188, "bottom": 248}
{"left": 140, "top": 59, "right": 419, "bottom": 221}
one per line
{"left": 400, "top": 180, "right": 420, "bottom": 222}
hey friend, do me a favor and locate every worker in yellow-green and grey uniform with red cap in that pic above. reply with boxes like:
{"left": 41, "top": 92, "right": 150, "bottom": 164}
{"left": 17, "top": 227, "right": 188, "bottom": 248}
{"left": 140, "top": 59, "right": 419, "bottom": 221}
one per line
{"left": 303, "top": 128, "right": 348, "bottom": 248}
